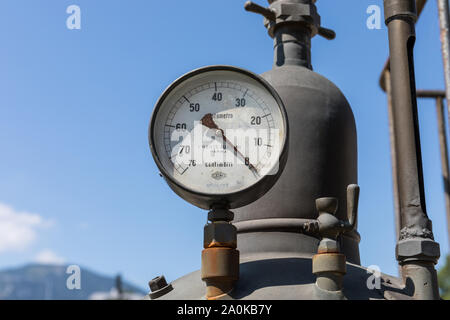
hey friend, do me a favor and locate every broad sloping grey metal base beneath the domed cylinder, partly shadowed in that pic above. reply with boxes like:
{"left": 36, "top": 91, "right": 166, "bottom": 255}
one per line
{"left": 154, "top": 253, "right": 411, "bottom": 300}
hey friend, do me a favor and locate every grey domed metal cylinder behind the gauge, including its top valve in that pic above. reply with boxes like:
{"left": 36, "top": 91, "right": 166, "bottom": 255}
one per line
{"left": 235, "top": 0, "right": 360, "bottom": 264}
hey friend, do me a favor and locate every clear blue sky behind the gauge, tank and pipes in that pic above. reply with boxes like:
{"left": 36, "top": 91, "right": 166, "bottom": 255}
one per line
{"left": 0, "top": 0, "right": 448, "bottom": 287}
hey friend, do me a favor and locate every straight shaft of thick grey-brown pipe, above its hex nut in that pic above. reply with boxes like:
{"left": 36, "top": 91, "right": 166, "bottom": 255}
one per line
{"left": 385, "top": 0, "right": 431, "bottom": 238}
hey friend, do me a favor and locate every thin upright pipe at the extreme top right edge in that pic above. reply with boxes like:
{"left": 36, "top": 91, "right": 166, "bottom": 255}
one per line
{"left": 437, "top": 0, "right": 450, "bottom": 120}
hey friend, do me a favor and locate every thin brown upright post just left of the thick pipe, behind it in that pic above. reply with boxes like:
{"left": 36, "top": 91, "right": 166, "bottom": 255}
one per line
{"left": 384, "top": 69, "right": 401, "bottom": 240}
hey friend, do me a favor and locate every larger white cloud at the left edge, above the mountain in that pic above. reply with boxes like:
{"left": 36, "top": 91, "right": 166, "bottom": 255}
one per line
{"left": 0, "top": 203, "right": 52, "bottom": 252}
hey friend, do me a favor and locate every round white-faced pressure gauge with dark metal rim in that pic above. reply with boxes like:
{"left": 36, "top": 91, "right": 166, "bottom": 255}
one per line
{"left": 149, "top": 66, "right": 288, "bottom": 209}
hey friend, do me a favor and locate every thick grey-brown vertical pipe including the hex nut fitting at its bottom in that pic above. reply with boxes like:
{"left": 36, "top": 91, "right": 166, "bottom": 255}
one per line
{"left": 384, "top": 0, "right": 439, "bottom": 299}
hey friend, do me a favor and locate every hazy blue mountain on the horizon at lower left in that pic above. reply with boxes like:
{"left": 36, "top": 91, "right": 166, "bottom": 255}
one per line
{"left": 0, "top": 264, "right": 146, "bottom": 300}
